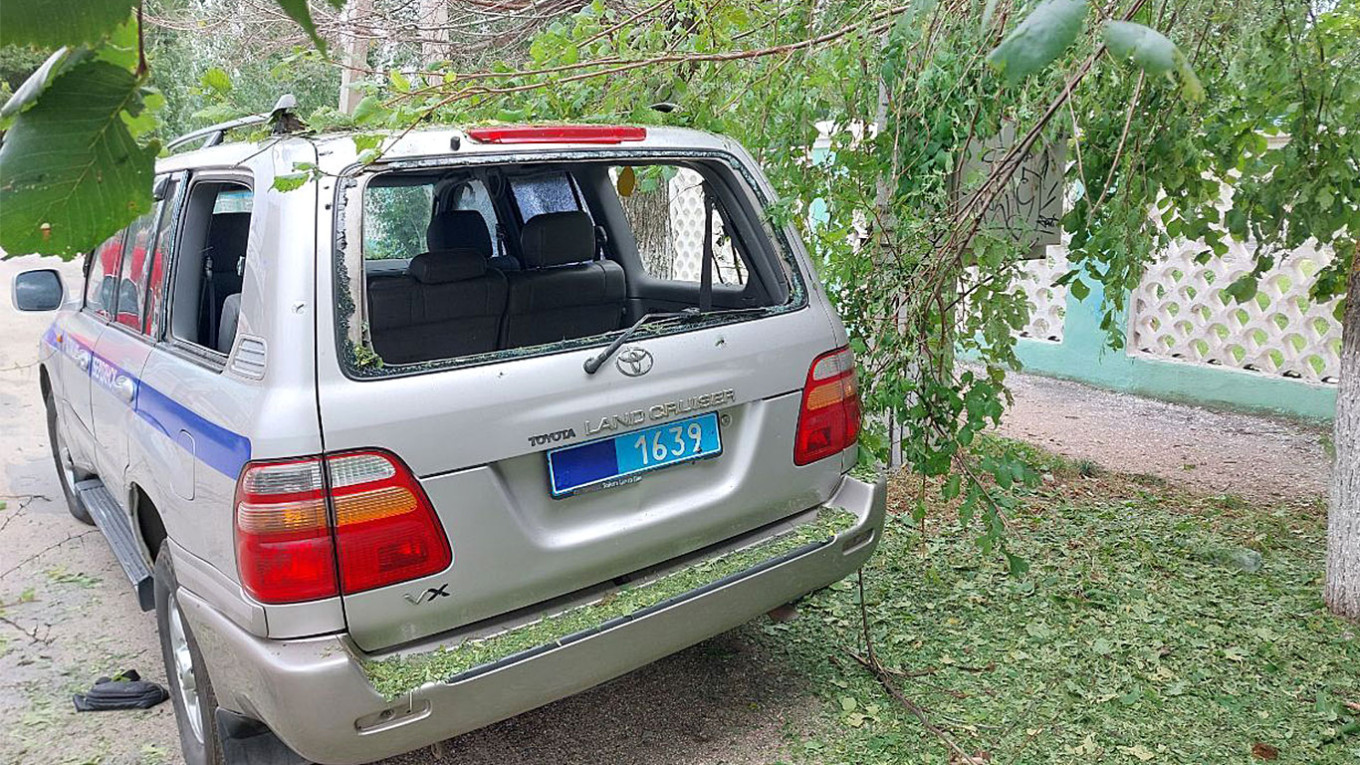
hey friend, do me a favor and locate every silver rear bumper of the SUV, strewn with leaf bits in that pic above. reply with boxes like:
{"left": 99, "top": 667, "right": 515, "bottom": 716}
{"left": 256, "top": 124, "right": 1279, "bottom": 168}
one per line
{"left": 180, "top": 476, "right": 885, "bottom": 765}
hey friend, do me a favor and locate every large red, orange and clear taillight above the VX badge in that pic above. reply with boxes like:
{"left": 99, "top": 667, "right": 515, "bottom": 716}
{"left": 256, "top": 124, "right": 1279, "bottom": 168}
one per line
{"left": 235, "top": 451, "right": 453, "bottom": 603}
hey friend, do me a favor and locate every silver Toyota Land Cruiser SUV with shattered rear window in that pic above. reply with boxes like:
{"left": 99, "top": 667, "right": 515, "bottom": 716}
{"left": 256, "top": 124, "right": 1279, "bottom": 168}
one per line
{"left": 15, "top": 112, "right": 884, "bottom": 764}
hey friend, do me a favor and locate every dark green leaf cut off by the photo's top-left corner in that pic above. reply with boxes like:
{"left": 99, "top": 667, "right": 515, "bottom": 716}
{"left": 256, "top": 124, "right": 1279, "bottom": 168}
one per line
{"left": 0, "top": 0, "right": 137, "bottom": 48}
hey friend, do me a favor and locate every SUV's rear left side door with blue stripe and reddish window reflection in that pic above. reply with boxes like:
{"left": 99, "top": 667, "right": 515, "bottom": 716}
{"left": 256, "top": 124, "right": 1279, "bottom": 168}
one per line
{"left": 90, "top": 183, "right": 176, "bottom": 500}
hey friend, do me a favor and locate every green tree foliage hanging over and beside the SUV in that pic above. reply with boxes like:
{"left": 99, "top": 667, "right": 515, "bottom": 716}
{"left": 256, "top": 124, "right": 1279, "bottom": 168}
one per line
{"left": 0, "top": 0, "right": 1360, "bottom": 569}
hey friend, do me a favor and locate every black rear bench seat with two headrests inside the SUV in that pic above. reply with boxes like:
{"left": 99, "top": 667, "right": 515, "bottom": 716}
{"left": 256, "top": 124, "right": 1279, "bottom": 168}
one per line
{"left": 369, "top": 211, "right": 626, "bottom": 363}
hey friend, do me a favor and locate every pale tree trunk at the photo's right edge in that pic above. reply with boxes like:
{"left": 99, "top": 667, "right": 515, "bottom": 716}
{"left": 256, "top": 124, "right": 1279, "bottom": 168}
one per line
{"left": 1322, "top": 246, "right": 1360, "bottom": 621}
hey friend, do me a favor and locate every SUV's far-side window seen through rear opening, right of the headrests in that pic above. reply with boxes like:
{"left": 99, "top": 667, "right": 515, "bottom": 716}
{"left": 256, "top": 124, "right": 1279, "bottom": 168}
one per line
{"left": 609, "top": 165, "right": 749, "bottom": 286}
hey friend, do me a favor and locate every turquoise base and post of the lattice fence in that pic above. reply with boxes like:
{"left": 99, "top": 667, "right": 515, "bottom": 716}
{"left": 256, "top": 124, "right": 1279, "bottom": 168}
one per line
{"left": 1016, "top": 274, "right": 1337, "bottom": 421}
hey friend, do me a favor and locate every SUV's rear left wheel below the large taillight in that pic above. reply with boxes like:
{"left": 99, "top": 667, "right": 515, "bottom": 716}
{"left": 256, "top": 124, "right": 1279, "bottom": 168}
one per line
{"left": 154, "top": 543, "right": 226, "bottom": 765}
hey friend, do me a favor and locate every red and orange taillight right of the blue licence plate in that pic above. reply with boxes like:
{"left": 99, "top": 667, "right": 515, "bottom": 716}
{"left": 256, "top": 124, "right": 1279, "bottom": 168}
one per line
{"left": 793, "top": 348, "right": 860, "bottom": 466}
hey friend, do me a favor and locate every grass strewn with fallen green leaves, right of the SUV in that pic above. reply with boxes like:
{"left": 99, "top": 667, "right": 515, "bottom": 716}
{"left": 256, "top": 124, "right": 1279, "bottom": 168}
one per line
{"left": 760, "top": 453, "right": 1360, "bottom": 765}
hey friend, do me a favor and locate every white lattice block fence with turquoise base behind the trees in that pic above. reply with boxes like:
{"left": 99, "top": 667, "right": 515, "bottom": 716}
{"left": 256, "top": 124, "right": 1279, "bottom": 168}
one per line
{"left": 1017, "top": 242, "right": 1341, "bottom": 419}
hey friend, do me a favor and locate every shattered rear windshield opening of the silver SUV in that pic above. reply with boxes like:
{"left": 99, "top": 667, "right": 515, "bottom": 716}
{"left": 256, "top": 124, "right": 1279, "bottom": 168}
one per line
{"left": 337, "top": 157, "right": 804, "bottom": 374}
